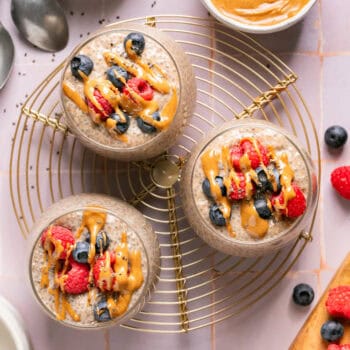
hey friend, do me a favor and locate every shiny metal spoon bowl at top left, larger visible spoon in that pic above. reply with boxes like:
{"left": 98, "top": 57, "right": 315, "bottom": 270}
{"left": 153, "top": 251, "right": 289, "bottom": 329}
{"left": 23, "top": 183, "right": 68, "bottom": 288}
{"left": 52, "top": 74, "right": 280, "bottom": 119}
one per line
{"left": 11, "top": 0, "right": 68, "bottom": 52}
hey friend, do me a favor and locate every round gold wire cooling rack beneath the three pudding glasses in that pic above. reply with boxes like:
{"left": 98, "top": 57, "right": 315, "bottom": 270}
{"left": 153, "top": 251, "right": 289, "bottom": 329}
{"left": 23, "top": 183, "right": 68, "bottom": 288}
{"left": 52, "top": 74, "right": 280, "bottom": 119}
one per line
{"left": 10, "top": 15, "right": 320, "bottom": 333}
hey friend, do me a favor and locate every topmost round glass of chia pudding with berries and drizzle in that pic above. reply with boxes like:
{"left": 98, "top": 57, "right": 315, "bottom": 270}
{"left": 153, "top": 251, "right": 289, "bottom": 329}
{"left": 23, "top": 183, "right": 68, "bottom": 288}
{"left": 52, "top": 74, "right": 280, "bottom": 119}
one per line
{"left": 61, "top": 24, "right": 196, "bottom": 161}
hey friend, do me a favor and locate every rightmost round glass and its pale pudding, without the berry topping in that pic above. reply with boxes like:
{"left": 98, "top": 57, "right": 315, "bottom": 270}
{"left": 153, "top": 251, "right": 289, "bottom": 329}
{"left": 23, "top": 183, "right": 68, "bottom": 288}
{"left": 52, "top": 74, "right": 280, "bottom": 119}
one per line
{"left": 181, "top": 119, "right": 318, "bottom": 257}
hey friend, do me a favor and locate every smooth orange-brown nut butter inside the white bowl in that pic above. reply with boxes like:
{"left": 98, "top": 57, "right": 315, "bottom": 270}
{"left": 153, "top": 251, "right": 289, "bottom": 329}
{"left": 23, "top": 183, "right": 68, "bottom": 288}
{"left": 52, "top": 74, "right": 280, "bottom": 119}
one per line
{"left": 211, "top": 0, "right": 309, "bottom": 26}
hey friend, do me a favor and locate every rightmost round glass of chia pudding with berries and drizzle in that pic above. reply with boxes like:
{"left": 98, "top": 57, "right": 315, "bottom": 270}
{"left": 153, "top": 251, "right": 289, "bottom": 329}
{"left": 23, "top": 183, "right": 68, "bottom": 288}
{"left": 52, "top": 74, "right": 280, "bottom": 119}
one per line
{"left": 181, "top": 120, "right": 317, "bottom": 256}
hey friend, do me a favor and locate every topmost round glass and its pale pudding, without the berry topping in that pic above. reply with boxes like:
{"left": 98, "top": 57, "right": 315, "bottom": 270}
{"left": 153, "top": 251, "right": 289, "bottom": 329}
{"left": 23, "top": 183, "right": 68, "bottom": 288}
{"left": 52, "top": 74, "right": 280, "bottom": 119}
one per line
{"left": 61, "top": 24, "right": 196, "bottom": 161}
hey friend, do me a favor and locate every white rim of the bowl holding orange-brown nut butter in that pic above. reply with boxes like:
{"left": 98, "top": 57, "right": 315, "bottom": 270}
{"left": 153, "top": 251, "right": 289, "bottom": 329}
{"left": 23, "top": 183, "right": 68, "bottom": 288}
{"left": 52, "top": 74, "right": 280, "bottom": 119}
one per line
{"left": 201, "top": 0, "right": 317, "bottom": 34}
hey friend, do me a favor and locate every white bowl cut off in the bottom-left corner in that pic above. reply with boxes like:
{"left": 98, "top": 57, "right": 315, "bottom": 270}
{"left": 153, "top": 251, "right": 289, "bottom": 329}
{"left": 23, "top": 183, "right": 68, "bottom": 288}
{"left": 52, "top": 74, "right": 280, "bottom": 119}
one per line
{"left": 0, "top": 296, "right": 31, "bottom": 350}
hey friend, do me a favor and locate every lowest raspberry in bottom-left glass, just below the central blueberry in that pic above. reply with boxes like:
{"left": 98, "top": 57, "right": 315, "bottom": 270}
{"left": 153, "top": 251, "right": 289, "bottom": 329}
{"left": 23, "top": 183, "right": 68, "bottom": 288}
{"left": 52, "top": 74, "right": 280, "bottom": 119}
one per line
{"left": 64, "top": 259, "right": 90, "bottom": 294}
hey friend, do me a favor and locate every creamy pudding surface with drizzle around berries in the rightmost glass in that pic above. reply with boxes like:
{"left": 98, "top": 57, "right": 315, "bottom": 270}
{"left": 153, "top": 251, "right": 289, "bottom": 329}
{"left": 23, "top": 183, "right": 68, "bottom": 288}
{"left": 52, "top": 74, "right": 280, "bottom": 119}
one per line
{"left": 192, "top": 127, "right": 309, "bottom": 242}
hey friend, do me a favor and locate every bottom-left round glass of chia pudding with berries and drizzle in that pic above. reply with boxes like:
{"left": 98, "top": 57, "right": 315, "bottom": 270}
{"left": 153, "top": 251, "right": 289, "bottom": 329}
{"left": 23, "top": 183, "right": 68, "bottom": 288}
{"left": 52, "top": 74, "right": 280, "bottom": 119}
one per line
{"left": 29, "top": 194, "right": 159, "bottom": 328}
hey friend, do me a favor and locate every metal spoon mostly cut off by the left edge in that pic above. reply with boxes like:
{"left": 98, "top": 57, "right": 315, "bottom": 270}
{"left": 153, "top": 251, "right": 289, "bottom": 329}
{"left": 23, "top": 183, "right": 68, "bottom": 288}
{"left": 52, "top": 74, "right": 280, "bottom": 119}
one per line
{"left": 0, "top": 22, "right": 15, "bottom": 90}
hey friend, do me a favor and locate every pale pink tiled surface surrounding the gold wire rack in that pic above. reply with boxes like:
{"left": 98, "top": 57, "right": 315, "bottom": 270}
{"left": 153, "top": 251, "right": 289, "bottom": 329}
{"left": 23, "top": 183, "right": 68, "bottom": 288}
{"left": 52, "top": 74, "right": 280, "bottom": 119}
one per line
{"left": 0, "top": 0, "right": 350, "bottom": 350}
